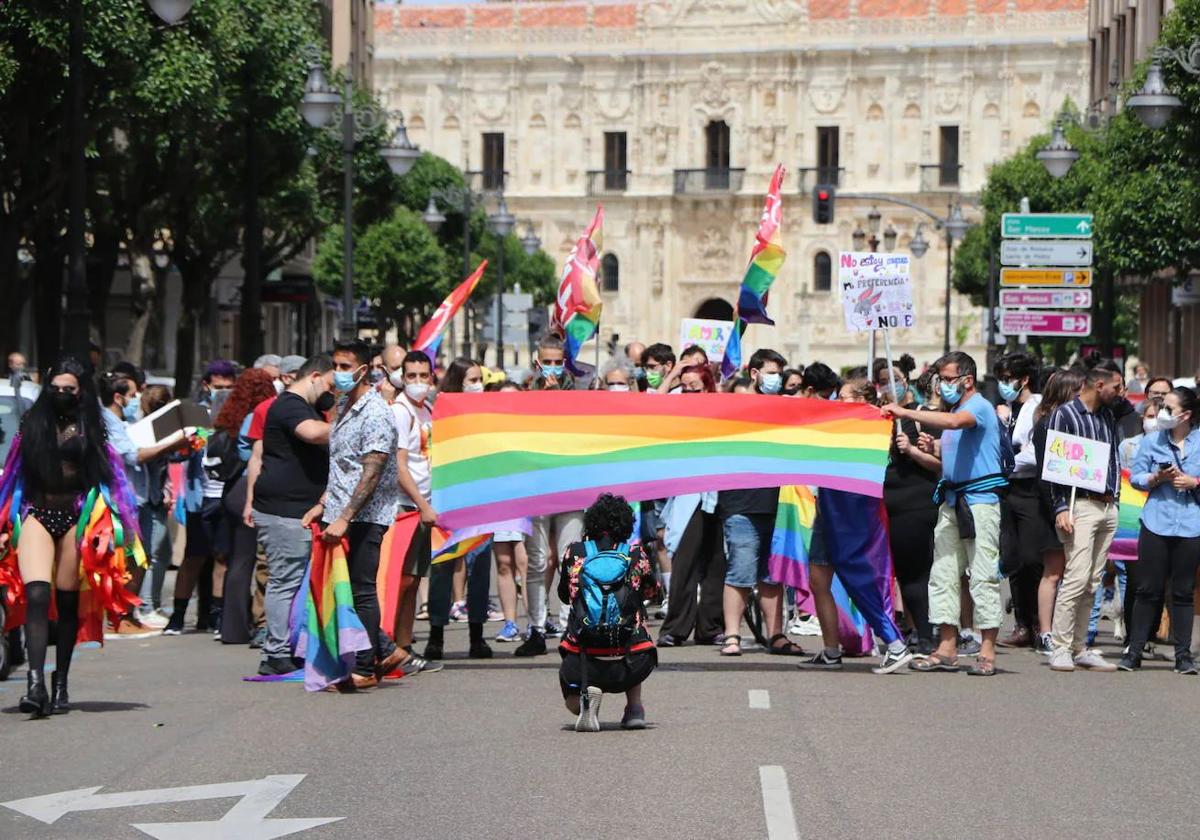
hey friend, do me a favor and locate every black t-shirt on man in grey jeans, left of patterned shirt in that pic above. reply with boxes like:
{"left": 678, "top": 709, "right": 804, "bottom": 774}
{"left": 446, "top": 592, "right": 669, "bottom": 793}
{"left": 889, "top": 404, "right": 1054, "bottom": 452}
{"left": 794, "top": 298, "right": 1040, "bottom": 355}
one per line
{"left": 254, "top": 391, "right": 329, "bottom": 520}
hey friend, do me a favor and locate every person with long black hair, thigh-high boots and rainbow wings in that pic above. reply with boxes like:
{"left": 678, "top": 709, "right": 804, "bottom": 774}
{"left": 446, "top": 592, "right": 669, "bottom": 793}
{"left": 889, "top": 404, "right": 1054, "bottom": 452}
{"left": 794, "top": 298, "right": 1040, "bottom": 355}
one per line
{"left": 0, "top": 358, "right": 145, "bottom": 718}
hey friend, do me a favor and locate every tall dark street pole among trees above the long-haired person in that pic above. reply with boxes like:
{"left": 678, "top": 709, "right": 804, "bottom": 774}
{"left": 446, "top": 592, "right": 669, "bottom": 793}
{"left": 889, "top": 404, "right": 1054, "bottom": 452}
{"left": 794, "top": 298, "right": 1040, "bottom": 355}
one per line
{"left": 62, "top": 0, "right": 91, "bottom": 367}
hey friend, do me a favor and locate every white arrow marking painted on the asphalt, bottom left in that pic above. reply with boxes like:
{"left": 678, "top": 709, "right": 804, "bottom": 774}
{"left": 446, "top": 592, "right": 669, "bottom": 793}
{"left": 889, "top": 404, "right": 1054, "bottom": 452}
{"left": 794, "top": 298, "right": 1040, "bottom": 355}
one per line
{"left": 0, "top": 775, "right": 342, "bottom": 840}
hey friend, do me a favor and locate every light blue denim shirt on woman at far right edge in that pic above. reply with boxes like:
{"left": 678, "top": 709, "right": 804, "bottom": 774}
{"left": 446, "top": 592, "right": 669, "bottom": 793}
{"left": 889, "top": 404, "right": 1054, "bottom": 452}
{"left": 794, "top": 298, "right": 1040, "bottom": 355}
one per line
{"left": 1129, "top": 428, "right": 1200, "bottom": 536}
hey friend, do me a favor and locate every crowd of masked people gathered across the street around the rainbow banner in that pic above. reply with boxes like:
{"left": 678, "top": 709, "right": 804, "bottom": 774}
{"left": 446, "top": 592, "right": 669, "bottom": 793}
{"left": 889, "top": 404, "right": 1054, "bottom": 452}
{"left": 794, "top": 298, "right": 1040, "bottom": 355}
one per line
{"left": 0, "top": 336, "right": 1200, "bottom": 728}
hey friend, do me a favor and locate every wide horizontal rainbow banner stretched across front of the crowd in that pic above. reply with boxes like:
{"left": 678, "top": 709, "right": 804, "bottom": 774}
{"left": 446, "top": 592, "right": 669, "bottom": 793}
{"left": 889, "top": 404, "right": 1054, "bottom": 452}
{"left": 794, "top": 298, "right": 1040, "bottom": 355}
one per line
{"left": 433, "top": 391, "right": 890, "bottom": 528}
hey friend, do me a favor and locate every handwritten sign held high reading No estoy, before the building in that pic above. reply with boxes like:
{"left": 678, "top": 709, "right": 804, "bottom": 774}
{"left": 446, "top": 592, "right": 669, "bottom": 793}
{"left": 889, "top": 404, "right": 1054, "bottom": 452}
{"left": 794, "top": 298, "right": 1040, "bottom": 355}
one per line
{"left": 838, "top": 251, "right": 917, "bottom": 332}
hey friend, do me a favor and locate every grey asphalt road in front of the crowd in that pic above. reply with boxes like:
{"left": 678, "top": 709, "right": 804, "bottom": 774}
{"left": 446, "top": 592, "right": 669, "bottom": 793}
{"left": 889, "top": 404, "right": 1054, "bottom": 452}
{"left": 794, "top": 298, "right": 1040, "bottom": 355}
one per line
{"left": 0, "top": 607, "right": 1200, "bottom": 840}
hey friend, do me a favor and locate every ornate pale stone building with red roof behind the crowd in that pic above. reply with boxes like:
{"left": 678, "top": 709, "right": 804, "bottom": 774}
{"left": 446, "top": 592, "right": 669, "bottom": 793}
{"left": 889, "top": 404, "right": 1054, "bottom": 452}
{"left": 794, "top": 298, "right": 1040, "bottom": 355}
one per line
{"left": 374, "top": 0, "right": 1088, "bottom": 367}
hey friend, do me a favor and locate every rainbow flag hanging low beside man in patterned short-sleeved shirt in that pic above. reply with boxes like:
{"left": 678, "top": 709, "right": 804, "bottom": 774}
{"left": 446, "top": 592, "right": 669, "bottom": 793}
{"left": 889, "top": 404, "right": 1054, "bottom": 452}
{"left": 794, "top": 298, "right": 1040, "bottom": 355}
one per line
{"left": 296, "top": 526, "right": 371, "bottom": 691}
